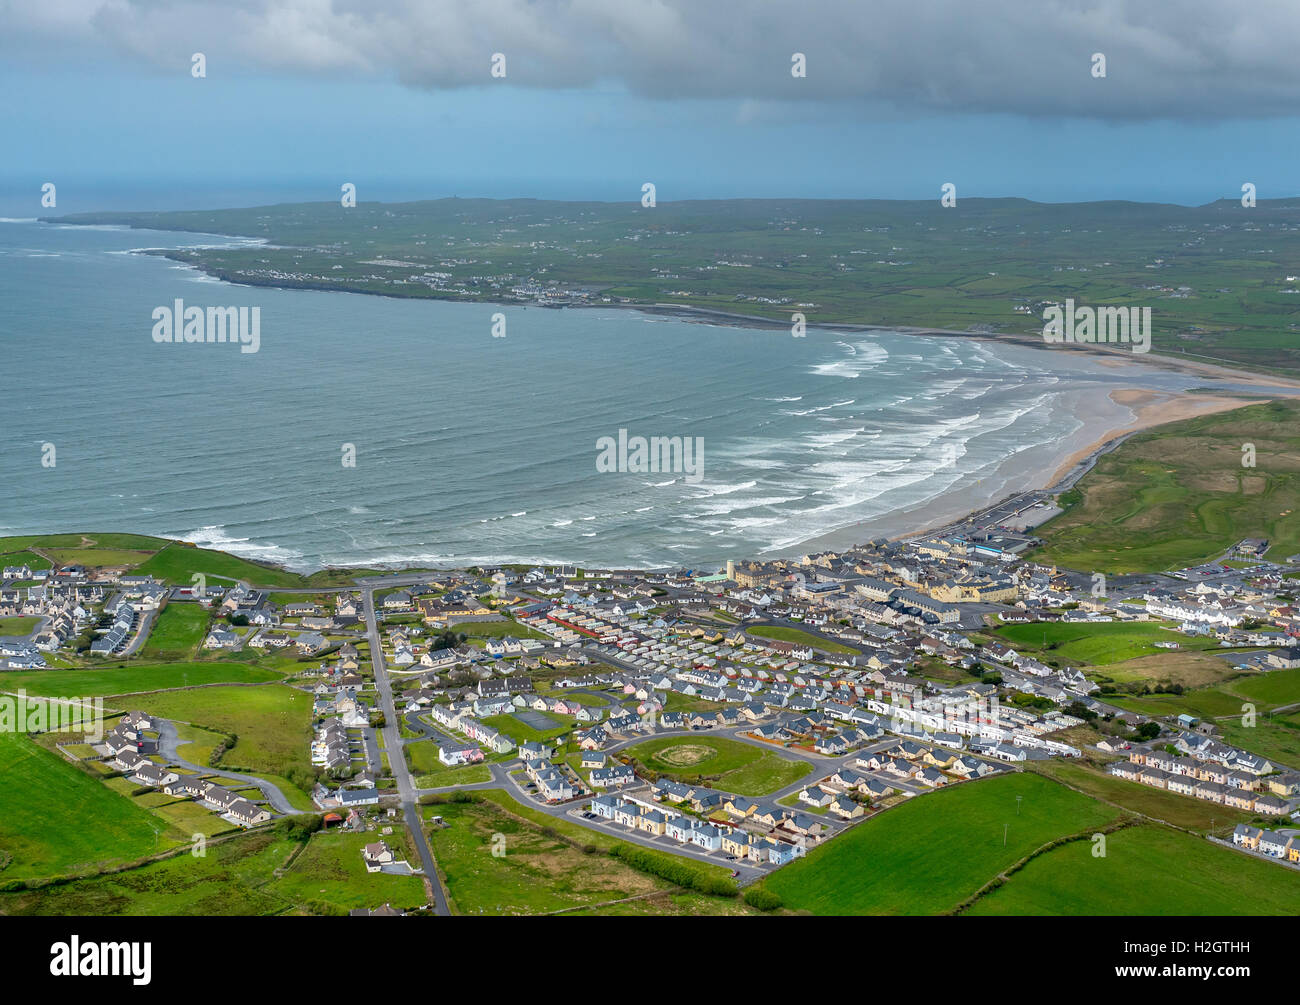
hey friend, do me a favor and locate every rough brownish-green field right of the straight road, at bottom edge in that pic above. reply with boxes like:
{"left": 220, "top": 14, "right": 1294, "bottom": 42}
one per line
{"left": 424, "top": 800, "right": 750, "bottom": 914}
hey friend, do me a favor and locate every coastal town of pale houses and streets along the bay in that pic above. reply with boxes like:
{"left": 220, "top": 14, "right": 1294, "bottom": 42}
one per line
{"left": 0, "top": 494, "right": 1300, "bottom": 913}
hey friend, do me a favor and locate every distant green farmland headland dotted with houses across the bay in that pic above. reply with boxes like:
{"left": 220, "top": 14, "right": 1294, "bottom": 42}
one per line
{"left": 57, "top": 199, "right": 1300, "bottom": 379}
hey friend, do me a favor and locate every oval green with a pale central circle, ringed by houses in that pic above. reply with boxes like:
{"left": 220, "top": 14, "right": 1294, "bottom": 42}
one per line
{"left": 623, "top": 735, "right": 813, "bottom": 796}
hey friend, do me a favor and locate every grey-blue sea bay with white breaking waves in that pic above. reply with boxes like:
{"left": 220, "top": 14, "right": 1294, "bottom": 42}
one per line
{"left": 0, "top": 220, "right": 1206, "bottom": 569}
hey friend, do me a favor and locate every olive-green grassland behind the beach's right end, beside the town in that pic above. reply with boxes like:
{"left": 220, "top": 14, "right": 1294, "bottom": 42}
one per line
{"left": 1030, "top": 400, "right": 1300, "bottom": 572}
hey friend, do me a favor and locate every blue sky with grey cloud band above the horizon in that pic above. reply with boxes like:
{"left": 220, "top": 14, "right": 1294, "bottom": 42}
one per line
{"left": 0, "top": 0, "right": 1300, "bottom": 217}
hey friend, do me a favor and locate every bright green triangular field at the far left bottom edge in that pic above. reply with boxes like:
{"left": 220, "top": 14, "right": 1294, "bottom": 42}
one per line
{"left": 0, "top": 733, "right": 175, "bottom": 883}
